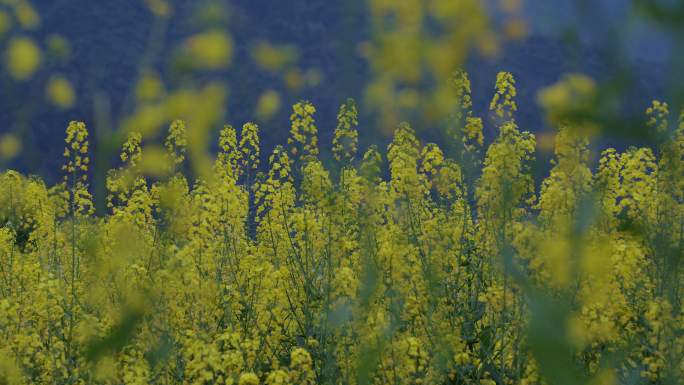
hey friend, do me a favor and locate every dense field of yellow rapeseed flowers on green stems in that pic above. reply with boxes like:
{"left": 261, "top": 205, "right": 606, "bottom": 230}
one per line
{"left": 0, "top": 73, "right": 684, "bottom": 385}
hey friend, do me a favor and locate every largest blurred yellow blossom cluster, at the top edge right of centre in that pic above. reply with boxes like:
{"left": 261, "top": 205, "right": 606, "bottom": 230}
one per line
{"left": 360, "top": 0, "right": 524, "bottom": 131}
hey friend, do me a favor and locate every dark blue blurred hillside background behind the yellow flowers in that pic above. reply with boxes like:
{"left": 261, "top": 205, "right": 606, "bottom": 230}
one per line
{"left": 0, "top": 0, "right": 673, "bottom": 182}
